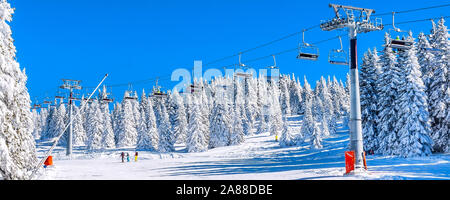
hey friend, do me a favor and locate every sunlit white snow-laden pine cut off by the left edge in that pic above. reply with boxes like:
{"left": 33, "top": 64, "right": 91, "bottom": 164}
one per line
{"left": 0, "top": 0, "right": 37, "bottom": 179}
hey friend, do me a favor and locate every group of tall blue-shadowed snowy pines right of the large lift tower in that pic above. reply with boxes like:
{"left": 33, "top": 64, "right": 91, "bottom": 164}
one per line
{"left": 360, "top": 18, "right": 450, "bottom": 157}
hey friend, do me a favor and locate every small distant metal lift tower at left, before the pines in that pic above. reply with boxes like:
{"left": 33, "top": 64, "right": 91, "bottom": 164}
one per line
{"left": 59, "top": 79, "right": 81, "bottom": 156}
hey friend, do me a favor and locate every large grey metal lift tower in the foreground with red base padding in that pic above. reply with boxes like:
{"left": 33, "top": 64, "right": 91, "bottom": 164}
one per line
{"left": 320, "top": 4, "right": 383, "bottom": 171}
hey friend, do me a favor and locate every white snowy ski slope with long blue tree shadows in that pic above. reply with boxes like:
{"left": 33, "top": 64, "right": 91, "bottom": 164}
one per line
{"left": 38, "top": 116, "right": 450, "bottom": 180}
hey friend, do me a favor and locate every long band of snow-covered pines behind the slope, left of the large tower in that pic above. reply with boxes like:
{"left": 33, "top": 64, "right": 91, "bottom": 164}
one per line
{"left": 33, "top": 75, "right": 349, "bottom": 152}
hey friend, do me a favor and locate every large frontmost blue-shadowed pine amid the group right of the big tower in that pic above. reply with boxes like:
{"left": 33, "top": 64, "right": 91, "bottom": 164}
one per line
{"left": 393, "top": 32, "right": 433, "bottom": 157}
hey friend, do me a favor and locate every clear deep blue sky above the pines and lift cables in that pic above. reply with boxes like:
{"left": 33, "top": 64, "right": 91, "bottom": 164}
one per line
{"left": 11, "top": 0, "right": 450, "bottom": 103}
